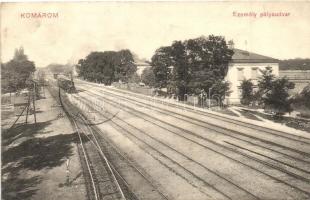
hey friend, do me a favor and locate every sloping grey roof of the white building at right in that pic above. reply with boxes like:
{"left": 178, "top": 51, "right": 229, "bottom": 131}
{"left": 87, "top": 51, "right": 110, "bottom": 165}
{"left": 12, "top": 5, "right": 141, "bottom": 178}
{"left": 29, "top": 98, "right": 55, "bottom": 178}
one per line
{"left": 232, "top": 49, "right": 279, "bottom": 63}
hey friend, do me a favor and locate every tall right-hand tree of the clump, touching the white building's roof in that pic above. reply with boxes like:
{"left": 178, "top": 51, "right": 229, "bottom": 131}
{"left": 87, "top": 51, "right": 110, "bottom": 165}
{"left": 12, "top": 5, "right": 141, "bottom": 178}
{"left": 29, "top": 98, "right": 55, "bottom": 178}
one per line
{"left": 185, "top": 35, "right": 233, "bottom": 93}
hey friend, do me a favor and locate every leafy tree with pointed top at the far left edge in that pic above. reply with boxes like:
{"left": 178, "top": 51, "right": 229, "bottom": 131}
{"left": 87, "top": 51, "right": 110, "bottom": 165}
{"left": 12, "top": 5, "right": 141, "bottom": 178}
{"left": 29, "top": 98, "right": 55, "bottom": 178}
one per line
{"left": 1, "top": 47, "right": 35, "bottom": 92}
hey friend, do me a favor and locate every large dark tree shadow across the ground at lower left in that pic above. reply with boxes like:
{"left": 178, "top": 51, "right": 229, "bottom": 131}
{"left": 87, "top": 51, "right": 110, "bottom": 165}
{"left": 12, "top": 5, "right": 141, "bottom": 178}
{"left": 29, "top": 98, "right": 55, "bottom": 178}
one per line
{"left": 1, "top": 121, "right": 86, "bottom": 200}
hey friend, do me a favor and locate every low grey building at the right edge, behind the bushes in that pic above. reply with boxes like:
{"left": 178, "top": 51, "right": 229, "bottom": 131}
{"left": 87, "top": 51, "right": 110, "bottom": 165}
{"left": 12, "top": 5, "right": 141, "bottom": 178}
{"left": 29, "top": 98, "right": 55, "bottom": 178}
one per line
{"left": 279, "top": 70, "right": 310, "bottom": 95}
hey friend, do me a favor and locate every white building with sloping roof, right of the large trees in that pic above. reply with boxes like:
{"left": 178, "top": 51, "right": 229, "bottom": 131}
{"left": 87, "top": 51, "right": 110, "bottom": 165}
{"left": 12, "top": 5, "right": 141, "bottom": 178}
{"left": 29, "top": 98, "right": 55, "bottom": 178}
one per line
{"left": 225, "top": 49, "right": 279, "bottom": 104}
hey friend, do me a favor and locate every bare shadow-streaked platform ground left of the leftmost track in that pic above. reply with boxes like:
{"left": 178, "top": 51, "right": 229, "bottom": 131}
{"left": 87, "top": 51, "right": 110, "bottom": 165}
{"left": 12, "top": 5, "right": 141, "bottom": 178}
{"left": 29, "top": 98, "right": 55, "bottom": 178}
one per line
{"left": 2, "top": 90, "right": 87, "bottom": 200}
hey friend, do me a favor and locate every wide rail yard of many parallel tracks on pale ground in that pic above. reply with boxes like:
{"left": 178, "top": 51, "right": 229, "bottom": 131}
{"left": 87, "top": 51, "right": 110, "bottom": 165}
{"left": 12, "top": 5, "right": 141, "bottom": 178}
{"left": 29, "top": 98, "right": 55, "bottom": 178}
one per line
{"left": 46, "top": 77, "right": 310, "bottom": 200}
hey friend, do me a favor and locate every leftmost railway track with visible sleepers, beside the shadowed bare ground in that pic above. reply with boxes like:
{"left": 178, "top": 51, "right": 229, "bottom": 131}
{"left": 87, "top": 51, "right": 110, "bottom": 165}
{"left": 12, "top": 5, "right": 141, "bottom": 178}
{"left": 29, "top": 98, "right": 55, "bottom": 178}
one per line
{"left": 49, "top": 84, "right": 126, "bottom": 200}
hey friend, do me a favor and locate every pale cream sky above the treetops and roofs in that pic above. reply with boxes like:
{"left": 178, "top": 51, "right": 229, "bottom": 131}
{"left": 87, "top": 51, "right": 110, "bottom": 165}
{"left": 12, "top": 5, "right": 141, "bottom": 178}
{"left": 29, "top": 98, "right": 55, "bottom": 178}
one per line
{"left": 0, "top": 2, "right": 310, "bottom": 67}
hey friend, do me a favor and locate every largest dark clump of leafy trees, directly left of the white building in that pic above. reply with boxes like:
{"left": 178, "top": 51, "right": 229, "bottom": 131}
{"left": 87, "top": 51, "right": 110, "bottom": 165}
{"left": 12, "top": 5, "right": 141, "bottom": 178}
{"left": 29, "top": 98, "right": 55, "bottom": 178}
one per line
{"left": 152, "top": 35, "right": 233, "bottom": 100}
